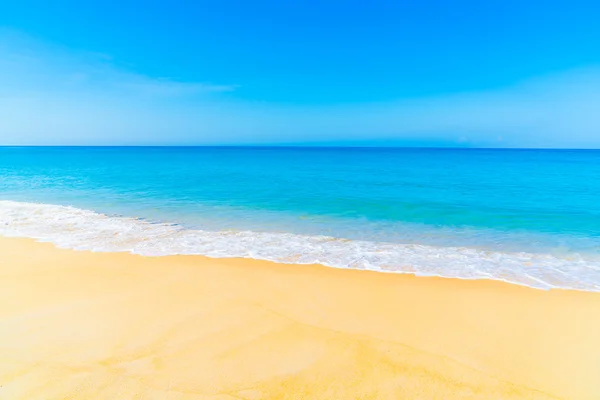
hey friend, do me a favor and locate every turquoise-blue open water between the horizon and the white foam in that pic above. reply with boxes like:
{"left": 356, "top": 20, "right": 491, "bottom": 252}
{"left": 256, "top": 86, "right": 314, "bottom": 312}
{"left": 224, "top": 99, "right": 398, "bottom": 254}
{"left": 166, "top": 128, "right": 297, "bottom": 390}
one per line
{"left": 0, "top": 147, "right": 600, "bottom": 290}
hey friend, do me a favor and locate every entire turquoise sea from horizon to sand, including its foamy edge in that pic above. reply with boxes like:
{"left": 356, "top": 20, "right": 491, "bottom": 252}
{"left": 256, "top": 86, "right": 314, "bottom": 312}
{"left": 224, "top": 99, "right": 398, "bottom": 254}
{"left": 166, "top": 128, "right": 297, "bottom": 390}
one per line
{"left": 0, "top": 147, "right": 600, "bottom": 291}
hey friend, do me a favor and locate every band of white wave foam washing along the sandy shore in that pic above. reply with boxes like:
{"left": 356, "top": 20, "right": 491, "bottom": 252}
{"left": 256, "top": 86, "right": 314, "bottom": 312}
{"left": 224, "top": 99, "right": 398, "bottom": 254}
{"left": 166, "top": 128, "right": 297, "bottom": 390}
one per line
{"left": 0, "top": 201, "right": 600, "bottom": 291}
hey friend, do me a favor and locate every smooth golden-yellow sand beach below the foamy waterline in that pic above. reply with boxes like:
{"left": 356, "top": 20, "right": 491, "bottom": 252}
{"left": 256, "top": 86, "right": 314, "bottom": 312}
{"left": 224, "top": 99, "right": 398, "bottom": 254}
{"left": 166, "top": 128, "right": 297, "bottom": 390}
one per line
{"left": 0, "top": 238, "right": 600, "bottom": 400}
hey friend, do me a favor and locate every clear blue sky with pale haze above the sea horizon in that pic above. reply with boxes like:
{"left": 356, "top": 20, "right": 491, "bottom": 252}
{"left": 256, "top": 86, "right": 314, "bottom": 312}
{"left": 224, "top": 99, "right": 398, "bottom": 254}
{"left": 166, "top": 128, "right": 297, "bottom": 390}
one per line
{"left": 0, "top": 0, "right": 600, "bottom": 148}
